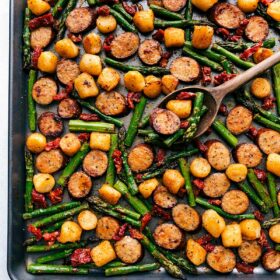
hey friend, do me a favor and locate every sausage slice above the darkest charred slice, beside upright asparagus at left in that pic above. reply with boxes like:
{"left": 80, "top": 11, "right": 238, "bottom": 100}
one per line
{"left": 32, "top": 77, "right": 57, "bottom": 105}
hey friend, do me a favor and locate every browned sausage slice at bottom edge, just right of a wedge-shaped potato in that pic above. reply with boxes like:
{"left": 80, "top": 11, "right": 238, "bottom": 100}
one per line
{"left": 206, "top": 246, "right": 236, "bottom": 273}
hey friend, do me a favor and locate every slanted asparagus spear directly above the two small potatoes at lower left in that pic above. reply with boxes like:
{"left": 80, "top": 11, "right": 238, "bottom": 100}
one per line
{"left": 33, "top": 203, "right": 89, "bottom": 228}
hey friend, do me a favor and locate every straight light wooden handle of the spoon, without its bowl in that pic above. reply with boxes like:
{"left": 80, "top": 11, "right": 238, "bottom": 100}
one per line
{"left": 211, "top": 52, "right": 280, "bottom": 101}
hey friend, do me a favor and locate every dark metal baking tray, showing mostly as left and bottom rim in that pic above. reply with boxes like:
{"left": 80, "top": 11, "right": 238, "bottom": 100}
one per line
{"left": 6, "top": 0, "right": 279, "bottom": 280}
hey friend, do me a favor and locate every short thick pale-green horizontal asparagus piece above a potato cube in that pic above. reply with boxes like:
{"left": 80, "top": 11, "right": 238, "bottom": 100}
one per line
{"left": 69, "top": 120, "right": 115, "bottom": 133}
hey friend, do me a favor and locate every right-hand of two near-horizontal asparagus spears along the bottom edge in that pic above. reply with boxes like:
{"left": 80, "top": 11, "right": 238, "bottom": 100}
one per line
{"left": 105, "top": 263, "right": 160, "bottom": 276}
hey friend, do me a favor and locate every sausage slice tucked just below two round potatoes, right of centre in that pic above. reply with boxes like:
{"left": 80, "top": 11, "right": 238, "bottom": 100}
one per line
{"left": 203, "top": 173, "right": 230, "bottom": 198}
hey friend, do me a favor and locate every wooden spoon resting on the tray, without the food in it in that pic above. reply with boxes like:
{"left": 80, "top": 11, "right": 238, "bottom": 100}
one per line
{"left": 158, "top": 52, "right": 280, "bottom": 138}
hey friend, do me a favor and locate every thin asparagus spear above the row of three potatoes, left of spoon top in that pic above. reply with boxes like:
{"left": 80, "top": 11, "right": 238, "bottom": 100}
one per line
{"left": 104, "top": 57, "right": 170, "bottom": 75}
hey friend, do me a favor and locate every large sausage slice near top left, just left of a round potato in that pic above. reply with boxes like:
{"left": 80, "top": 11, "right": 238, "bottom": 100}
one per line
{"left": 65, "top": 8, "right": 95, "bottom": 33}
